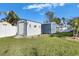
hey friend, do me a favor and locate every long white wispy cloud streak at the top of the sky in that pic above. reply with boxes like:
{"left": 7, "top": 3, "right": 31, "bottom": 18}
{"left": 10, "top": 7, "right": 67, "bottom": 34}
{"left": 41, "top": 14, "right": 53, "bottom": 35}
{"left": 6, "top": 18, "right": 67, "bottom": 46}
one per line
{"left": 23, "top": 3, "right": 64, "bottom": 10}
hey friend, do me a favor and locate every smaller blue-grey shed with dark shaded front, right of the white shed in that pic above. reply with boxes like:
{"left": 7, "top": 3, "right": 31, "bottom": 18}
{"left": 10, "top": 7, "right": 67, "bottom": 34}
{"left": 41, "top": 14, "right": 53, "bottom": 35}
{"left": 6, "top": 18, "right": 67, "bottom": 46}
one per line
{"left": 41, "top": 22, "right": 57, "bottom": 34}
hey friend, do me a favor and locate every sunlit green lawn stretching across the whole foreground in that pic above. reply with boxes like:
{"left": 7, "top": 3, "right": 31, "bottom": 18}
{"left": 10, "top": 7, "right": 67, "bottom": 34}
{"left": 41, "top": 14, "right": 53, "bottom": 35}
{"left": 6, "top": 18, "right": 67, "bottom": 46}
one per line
{"left": 0, "top": 36, "right": 79, "bottom": 56}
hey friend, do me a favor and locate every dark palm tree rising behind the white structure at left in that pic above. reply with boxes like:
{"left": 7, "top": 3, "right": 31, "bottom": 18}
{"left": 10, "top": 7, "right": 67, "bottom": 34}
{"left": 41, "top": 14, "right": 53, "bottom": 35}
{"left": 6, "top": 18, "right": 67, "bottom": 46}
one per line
{"left": 0, "top": 11, "right": 20, "bottom": 25}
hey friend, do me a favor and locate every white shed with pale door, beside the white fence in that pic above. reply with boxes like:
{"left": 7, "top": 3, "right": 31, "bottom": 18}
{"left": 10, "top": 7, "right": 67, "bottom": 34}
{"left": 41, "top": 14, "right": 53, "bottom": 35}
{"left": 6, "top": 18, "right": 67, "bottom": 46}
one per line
{"left": 17, "top": 20, "right": 41, "bottom": 36}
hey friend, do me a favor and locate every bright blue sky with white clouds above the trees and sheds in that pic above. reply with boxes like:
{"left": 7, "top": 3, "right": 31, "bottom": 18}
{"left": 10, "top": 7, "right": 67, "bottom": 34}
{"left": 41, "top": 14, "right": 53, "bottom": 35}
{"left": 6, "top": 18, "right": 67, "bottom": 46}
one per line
{"left": 0, "top": 3, "right": 79, "bottom": 23}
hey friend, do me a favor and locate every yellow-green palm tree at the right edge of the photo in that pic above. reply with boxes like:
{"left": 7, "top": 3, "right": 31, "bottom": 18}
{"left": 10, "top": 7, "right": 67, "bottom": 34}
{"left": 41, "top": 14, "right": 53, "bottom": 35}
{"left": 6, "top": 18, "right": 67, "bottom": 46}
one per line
{"left": 70, "top": 17, "right": 79, "bottom": 38}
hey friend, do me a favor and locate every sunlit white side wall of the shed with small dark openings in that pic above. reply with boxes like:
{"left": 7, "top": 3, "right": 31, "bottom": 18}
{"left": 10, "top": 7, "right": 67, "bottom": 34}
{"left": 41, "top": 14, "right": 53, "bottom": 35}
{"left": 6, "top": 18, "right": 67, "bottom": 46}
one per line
{"left": 27, "top": 21, "right": 41, "bottom": 36}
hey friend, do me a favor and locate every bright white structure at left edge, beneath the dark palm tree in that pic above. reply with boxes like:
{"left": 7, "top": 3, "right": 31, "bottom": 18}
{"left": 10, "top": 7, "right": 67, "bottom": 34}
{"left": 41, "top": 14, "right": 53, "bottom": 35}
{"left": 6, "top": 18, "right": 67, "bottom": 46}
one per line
{"left": 0, "top": 24, "right": 17, "bottom": 37}
